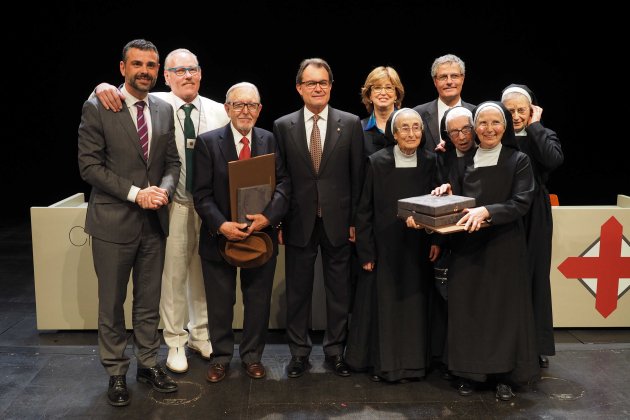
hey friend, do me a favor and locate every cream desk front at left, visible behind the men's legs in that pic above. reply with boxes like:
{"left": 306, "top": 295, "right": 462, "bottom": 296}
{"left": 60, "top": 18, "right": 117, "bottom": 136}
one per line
{"left": 31, "top": 193, "right": 326, "bottom": 330}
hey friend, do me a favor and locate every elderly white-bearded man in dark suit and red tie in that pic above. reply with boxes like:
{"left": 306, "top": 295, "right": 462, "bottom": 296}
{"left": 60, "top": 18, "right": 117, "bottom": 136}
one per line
{"left": 193, "top": 82, "right": 291, "bottom": 382}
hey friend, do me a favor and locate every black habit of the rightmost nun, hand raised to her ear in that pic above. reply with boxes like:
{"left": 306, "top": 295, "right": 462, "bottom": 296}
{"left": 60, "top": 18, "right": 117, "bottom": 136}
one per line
{"left": 516, "top": 123, "right": 564, "bottom": 356}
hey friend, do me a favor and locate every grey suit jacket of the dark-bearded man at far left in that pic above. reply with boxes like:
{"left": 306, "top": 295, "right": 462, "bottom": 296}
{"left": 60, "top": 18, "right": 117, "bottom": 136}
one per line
{"left": 79, "top": 95, "right": 181, "bottom": 243}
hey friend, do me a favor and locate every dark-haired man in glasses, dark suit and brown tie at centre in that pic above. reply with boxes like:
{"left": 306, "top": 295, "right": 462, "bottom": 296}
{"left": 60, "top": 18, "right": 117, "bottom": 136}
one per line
{"left": 273, "top": 58, "right": 365, "bottom": 378}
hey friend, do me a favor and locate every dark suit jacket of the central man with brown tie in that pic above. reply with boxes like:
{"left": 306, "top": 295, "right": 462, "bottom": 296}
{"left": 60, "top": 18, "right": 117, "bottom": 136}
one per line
{"left": 273, "top": 106, "right": 365, "bottom": 247}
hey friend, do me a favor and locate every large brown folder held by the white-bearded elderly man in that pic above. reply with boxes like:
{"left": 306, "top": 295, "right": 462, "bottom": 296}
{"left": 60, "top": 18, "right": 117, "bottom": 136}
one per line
{"left": 228, "top": 153, "right": 276, "bottom": 222}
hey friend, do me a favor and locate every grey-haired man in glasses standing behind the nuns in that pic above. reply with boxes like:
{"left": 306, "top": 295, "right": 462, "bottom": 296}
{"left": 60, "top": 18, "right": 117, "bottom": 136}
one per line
{"left": 414, "top": 54, "right": 475, "bottom": 155}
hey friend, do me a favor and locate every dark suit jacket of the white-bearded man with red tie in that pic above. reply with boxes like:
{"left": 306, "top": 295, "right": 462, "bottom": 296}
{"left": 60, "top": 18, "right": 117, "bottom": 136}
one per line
{"left": 193, "top": 123, "right": 291, "bottom": 261}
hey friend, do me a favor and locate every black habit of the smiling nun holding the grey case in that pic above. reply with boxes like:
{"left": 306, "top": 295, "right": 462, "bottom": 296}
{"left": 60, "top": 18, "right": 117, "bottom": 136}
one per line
{"left": 448, "top": 146, "right": 539, "bottom": 383}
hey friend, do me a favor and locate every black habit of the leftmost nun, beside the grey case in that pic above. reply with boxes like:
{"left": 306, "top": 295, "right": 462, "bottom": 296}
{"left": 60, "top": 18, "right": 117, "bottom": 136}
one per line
{"left": 346, "top": 146, "right": 436, "bottom": 381}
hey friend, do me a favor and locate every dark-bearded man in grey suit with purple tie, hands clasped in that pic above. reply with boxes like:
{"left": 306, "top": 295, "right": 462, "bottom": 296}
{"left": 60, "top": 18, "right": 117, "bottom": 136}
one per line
{"left": 78, "top": 39, "right": 181, "bottom": 406}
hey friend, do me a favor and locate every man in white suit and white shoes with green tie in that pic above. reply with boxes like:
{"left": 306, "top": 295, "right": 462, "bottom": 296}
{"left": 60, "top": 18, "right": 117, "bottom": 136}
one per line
{"left": 94, "top": 48, "right": 230, "bottom": 373}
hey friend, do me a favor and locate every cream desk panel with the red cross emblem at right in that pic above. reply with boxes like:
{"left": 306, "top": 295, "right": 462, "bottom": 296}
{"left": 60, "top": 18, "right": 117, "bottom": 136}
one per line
{"left": 551, "top": 195, "right": 630, "bottom": 327}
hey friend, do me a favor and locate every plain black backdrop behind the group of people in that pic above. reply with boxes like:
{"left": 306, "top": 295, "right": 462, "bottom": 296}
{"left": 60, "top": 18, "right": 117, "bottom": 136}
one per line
{"left": 7, "top": 1, "right": 630, "bottom": 223}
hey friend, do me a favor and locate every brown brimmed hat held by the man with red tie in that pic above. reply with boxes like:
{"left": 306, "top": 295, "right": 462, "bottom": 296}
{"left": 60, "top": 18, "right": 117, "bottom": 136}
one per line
{"left": 219, "top": 232, "right": 273, "bottom": 268}
